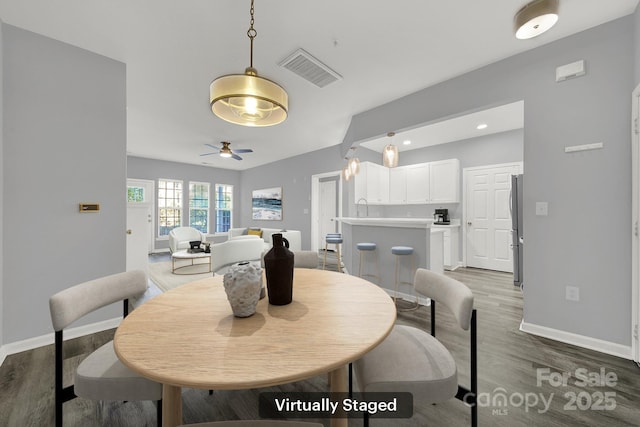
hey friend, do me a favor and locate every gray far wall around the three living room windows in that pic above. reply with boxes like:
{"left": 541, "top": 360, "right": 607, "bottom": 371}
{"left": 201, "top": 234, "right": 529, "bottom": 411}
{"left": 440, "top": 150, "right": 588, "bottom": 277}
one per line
{"left": 127, "top": 156, "right": 241, "bottom": 250}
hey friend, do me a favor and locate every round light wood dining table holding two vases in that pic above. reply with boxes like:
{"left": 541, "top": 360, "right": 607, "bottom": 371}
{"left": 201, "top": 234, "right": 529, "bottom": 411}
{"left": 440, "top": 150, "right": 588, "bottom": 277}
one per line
{"left": 114, "top": 269, "right": 396, "bottom": 427}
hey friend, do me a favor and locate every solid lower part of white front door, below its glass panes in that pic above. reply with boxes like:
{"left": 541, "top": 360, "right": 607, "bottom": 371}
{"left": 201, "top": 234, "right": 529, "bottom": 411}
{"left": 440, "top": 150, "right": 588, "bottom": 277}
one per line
{"left": 127, "top": 203, "right": 149, "bottom": 273}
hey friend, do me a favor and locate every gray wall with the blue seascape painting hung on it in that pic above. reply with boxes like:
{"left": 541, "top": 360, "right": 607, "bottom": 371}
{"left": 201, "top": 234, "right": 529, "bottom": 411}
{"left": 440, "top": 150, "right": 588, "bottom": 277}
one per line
{"left": 240, "top": 145, "right": 346, "bottom": 249}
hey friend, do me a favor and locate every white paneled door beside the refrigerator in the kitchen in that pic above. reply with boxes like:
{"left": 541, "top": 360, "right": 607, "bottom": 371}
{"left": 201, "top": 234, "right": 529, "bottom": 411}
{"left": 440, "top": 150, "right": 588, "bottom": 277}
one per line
{"left": 464, "top": 164, "right": 521, "bottom": 272}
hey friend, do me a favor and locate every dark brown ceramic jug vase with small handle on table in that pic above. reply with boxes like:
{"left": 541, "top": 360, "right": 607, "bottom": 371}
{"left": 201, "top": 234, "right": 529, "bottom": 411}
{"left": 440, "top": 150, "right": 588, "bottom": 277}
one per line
{"left": 264, "top": 233, "right": 293, "bottom": 305}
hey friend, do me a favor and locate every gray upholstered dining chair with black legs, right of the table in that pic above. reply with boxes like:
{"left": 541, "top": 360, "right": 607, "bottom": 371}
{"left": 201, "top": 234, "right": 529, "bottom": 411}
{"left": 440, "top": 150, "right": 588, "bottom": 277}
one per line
{"left": 353, "top": 268, "right": 478, "bottom": 427}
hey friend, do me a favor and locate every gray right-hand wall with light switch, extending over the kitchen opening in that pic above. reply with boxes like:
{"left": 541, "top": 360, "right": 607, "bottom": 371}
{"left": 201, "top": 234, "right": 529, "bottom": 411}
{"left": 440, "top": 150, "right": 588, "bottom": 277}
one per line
{"left": 341, "top": 16, "right": 637, "bottom": 345}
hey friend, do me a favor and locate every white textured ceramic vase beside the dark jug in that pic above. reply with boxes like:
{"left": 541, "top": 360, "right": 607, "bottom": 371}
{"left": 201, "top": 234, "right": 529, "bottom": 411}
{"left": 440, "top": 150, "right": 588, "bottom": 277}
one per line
{"left": 223, "top": 261, "right": 262, "bottom": 317}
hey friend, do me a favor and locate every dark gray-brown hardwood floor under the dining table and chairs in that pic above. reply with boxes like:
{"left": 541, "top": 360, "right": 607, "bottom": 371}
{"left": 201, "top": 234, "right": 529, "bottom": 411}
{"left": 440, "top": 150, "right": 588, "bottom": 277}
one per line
{"left": 0, "top": 269, "right": 640, "bottom": 427}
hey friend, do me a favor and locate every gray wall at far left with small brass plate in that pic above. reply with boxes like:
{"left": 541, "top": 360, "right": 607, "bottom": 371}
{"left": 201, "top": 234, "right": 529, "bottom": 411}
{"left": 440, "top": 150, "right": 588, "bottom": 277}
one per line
{"left": 2, "top": 24, "right": 126, "bottom": 342}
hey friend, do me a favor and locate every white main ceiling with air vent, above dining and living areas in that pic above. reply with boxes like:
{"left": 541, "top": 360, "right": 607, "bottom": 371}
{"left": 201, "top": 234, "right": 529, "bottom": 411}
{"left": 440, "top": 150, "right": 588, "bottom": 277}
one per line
{"left": 0, "top": 0, "right": 638, "bottom": 170}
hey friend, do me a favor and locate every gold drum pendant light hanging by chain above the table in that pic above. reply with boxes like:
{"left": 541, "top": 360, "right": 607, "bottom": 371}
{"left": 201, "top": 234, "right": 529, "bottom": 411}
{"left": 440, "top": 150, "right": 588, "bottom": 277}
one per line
{"left": 209, "top": 0, "right": 289, "bottom": 126}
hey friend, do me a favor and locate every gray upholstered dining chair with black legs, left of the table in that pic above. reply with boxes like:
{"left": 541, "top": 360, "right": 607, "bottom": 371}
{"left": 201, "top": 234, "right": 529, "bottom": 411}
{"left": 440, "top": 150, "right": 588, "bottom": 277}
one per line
{"left": 49, "top": 271, "right": 162, "bottom": 427}
